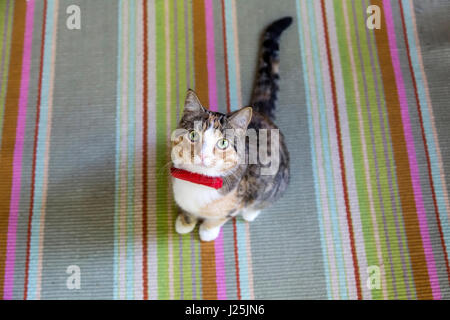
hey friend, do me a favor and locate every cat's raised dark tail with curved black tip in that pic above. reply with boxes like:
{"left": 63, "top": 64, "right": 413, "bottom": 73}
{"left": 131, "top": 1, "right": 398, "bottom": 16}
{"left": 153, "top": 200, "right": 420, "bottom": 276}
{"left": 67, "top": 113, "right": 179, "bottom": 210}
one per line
{"left": 251, "top": 17, "right": 292, "bottom": 119}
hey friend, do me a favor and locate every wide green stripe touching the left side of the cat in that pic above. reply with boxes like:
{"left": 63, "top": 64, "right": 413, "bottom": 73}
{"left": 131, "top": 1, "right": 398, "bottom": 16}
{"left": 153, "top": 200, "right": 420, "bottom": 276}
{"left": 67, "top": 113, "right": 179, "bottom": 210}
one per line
{"left": 155, "top": 1, "right": 169, "bottom": 300}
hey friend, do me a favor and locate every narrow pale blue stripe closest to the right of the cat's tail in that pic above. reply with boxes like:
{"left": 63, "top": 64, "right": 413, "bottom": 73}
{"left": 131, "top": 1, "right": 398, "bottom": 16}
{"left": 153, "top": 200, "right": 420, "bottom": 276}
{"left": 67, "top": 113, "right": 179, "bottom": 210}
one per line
{"left": 295, "top": 0, "right": 332, "bottom": 299}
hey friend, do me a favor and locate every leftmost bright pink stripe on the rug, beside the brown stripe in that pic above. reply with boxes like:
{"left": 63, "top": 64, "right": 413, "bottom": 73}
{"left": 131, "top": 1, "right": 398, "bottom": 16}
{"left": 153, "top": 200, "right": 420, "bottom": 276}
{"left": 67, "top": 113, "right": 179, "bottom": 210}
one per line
{"left": 3, "top": 0, "right": 34, "bottom": 300}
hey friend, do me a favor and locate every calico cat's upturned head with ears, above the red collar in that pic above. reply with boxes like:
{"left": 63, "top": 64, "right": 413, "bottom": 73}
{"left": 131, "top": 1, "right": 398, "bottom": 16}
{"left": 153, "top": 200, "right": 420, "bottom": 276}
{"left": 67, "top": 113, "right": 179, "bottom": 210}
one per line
{"left": 171, "top": 90, "right": 252, "bottom": 177}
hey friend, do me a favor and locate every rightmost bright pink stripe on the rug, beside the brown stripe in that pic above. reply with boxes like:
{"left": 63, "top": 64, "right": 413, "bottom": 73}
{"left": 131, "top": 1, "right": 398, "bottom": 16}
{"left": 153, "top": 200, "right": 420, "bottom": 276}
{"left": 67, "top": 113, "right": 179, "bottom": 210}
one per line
{"left": 383, "top": 0, "right": 441, "bottom": 299}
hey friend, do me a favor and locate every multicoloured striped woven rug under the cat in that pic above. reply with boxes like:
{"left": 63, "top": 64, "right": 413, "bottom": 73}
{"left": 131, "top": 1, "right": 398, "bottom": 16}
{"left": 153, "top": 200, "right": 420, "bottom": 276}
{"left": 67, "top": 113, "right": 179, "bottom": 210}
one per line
{"left": 0, "top": 0, "right": 450, "bottom": 299}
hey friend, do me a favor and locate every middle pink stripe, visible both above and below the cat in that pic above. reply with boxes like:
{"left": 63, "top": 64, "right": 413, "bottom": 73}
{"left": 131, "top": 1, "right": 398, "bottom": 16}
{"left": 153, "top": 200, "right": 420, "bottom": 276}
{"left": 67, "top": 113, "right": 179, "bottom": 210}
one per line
{"left": 205, "top": 0, "right": 227, "bottom": 300}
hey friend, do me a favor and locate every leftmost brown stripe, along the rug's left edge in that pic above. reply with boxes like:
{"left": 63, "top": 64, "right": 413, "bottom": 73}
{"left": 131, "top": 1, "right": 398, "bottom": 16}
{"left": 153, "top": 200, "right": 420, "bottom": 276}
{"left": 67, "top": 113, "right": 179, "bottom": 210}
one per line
{"left": 0, "top": 0, "right": 26, "bottom": 298}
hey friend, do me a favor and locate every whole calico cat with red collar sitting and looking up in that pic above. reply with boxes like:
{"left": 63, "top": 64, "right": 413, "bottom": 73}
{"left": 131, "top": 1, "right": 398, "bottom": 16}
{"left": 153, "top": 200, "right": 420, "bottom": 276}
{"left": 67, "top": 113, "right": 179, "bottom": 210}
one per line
{"left": 171, "top": 17, "right": 292, "bottom": 241}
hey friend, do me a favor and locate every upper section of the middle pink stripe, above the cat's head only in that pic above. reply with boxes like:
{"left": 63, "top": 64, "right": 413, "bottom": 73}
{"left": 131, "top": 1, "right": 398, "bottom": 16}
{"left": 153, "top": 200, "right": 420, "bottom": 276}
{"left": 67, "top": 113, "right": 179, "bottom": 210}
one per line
{"left": 205, "top": 0, "right": 217, "bottom": 111}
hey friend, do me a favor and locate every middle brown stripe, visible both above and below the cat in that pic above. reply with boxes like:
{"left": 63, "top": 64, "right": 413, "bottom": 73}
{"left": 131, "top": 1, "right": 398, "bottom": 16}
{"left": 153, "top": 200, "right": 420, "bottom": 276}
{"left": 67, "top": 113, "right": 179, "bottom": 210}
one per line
{"left": 192, "top": 0, "right": 217, "bottom": 300}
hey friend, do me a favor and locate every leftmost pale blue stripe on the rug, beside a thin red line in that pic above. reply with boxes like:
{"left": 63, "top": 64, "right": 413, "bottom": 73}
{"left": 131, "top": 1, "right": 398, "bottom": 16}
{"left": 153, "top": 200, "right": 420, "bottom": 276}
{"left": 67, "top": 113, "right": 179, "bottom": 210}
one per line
{"left": 28, "top": 0, "right": 55, "bottom": 300}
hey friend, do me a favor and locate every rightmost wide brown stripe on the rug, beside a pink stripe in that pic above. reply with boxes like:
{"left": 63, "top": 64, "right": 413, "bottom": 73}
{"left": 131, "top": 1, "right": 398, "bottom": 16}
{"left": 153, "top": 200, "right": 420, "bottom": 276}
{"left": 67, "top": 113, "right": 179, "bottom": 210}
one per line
{"left": 371, "top": 0, "right": 433, "bottom": 299}
